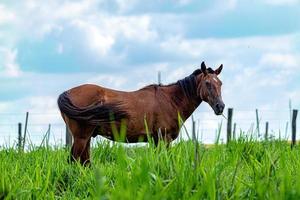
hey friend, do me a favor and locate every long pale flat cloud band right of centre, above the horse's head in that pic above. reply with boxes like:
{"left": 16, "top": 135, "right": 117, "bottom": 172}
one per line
{"left": 160, "top": 35, "right": 294, "bottom": 58}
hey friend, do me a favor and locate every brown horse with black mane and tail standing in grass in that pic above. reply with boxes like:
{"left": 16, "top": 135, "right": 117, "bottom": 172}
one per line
{"left": 58, "top": 62, "right": 225, "bottom": 164}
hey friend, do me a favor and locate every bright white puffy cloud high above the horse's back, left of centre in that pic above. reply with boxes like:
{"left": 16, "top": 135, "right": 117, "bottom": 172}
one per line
{"left": 72, "top": 15, "right": 157, "bottom": 56}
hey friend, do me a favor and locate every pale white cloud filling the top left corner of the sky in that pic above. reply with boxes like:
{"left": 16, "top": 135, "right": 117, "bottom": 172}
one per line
{"left": 0, "top": 0, "right": 97, "bottom": 41}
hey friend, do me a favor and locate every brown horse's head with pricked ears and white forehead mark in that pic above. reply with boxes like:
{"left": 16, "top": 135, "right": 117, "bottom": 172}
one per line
{"left": 197, "top": 62, "right": 225, "bottom": 115}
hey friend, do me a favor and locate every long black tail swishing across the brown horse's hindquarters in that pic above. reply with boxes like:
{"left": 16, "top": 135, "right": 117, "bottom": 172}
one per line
{"left": 57, "top": 91, "right": 128, "bottom": 125}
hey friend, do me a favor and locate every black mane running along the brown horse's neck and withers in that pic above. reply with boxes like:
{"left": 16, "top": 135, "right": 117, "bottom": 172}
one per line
{"left": 142, "top": 68, "right": 214, "bottom": 98}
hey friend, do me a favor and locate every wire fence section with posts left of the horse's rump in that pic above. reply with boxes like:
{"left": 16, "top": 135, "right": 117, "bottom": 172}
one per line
{"left": 0, "top": 113, "right": 65, "bottom": 149}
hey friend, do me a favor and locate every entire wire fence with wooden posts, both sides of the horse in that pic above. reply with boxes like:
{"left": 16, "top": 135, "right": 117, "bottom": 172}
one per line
{"left": 0, "top": 108, "right": 298, "bottom": 149}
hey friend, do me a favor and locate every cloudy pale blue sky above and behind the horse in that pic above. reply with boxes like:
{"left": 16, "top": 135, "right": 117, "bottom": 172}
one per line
{"left": 0, "top": 0, "right": 300, "bottom": 144}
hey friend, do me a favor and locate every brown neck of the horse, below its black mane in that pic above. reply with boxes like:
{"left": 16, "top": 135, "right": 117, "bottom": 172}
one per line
{"left": 171, "top": 84, "right": 202, "bottom": 120}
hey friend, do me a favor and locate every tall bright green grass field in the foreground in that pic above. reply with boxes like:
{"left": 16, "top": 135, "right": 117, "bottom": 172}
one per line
{"left": 0, "top": 139, "right": 300, "bottom": 199}
